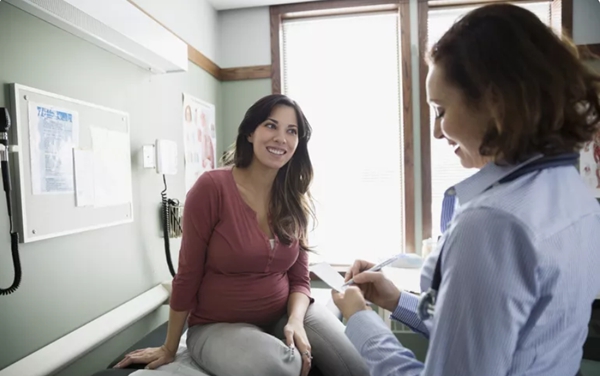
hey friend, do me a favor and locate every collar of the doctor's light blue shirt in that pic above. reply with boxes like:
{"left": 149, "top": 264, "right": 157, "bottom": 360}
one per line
{"left": 446, "top": 154, "right": 542, "bottom": 205}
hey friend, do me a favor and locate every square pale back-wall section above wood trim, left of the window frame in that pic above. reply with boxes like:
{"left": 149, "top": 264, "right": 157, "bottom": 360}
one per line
{"left": 219, "top": 7, "right": 271, "bottom": 68}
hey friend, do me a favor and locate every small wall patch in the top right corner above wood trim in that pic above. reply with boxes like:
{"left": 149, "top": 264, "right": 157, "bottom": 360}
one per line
{"left": 573, "top": 0, "right": 600, "bottom": 44}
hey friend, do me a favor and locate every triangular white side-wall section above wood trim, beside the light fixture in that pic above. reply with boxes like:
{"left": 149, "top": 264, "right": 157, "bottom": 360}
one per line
{"left": 133, "top": 0, "right": 219, "bottom": 65}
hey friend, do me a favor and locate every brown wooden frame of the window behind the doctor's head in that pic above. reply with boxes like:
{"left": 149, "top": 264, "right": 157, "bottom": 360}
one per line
{"left": 417, "top": 0, "right": 573, "bottom": 239}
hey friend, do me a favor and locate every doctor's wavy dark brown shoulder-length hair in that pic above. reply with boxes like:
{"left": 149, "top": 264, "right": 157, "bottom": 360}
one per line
{"left": 428, "top": 4, "right": 600, "bottom": 164}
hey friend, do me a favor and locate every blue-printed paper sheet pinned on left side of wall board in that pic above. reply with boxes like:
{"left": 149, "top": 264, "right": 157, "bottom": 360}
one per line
{"left": 28, "top": 102, "right": 79, "bottom": 195}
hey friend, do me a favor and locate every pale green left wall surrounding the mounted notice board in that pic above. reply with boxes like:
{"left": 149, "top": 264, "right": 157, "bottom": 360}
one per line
{"left": 0, "top": 2, "right": 223, "bottom": 376}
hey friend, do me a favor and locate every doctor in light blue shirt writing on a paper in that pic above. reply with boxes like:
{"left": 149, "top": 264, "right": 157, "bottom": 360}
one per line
{"left": 333, "top": 4, "right": 600, "bottom": 376}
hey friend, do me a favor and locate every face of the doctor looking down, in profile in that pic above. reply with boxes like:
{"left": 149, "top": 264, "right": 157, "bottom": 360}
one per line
{"left": 427, "top": 64, "right": 491, "bottom": 168}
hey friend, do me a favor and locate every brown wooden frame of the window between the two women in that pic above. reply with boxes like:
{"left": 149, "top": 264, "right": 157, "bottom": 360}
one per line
{"left": 269, "top": 0, "right": 416, "bottom": 253}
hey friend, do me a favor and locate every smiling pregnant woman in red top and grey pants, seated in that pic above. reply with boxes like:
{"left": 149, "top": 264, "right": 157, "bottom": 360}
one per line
{"left": 110, "top": 95, "right": 369, "bottom": 376}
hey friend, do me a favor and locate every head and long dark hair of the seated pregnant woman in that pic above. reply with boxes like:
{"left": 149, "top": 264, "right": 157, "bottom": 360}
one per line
{"left": 224, "top": 95, "right": 313, "bottom": 250}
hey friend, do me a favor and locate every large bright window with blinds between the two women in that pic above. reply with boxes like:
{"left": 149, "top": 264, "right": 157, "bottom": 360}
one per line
{"left": 281, "top": 11, "right": 412, "bottom": 264}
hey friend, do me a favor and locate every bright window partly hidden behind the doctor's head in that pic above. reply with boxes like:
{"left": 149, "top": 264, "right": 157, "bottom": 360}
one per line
{"left": 422, "top": 1, "right": 551, "bottom": 239}
